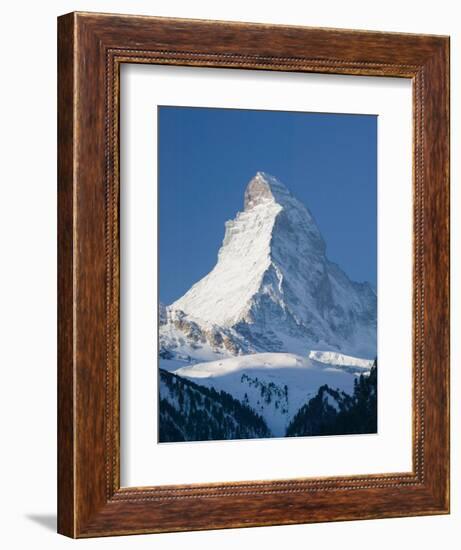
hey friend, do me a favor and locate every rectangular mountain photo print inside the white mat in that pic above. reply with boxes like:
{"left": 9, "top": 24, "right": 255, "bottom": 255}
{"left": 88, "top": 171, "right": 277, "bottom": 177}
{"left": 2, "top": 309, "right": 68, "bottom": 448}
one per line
{"left": 154, "top": 106, "right": 378, "bottom": 443}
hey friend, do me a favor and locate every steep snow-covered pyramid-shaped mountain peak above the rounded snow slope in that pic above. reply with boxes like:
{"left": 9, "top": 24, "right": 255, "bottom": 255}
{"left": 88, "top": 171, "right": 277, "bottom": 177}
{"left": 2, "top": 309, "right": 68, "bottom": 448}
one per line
{"left": 160, "top": 172, "right": 376, "bottom": 362}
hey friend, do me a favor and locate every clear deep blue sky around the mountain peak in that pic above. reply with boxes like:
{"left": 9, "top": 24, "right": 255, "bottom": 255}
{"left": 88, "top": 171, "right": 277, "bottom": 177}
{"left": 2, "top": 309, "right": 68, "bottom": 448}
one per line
{"left": 158, "top": 106, "right": 377, "bottom": 304}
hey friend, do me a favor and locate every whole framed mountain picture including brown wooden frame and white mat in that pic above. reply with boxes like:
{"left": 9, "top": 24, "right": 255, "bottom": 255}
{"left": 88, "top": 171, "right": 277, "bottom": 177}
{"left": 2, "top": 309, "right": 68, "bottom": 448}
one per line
{"left": 58, "top": 13, "right": 449, "bottom": 538}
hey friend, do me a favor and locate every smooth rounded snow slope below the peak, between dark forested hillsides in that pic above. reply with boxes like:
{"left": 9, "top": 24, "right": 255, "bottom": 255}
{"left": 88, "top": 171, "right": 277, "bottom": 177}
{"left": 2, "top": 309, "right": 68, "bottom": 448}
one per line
{"left": 174, "top": 353, "right": 355, "bottom": 437}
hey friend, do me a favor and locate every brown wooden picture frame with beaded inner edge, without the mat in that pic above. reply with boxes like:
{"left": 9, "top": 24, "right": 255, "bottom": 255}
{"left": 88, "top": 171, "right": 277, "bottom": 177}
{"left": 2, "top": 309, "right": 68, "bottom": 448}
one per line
{"left": 58, "top": 13, "right": 449, "bottom": 537}
